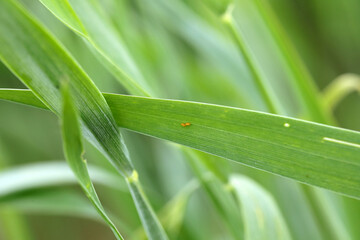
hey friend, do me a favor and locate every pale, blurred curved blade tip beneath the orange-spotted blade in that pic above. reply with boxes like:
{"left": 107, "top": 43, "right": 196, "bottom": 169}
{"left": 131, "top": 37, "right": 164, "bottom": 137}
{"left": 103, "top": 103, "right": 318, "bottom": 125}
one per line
{"left": 230, "top": 175, "right": 291, "bottom": 240}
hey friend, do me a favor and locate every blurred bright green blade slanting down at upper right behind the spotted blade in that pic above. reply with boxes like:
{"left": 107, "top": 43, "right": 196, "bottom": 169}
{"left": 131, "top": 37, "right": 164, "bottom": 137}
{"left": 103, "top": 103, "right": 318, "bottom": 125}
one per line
{"left": 233, "top": 0, "right": 331, "bottom": 123}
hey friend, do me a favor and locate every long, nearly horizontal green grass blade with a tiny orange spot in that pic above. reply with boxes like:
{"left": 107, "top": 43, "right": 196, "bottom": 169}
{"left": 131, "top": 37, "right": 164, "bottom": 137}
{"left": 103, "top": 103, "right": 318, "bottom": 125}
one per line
{"left": 0, "top": 90, "right": 360, "bottom": 198}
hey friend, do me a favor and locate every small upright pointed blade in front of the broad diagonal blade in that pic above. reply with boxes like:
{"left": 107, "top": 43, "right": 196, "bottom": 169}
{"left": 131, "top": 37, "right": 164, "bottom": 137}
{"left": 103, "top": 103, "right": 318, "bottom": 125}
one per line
{"left": 61, "top": 85, "right": 123, "bottom": 240}
